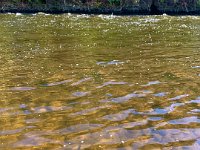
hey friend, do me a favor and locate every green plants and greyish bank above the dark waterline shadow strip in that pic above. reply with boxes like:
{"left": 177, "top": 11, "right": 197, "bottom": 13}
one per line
{"left": 0, "top": 0, "right": 200, "bottom": 12}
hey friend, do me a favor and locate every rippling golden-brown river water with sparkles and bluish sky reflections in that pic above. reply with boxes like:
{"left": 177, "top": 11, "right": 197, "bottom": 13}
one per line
{"left": 0, "top": 13, "right": 200, "bottom": 150}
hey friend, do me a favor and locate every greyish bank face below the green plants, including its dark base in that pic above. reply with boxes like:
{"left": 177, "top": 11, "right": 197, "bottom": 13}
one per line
{"left": 0, "top": 2, "right": 200, "bottom": 15}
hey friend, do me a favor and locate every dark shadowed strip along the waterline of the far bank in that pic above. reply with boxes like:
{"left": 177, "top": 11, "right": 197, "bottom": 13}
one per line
{"left": 0, "top": 8, "right": 200, "bottom": 16}
